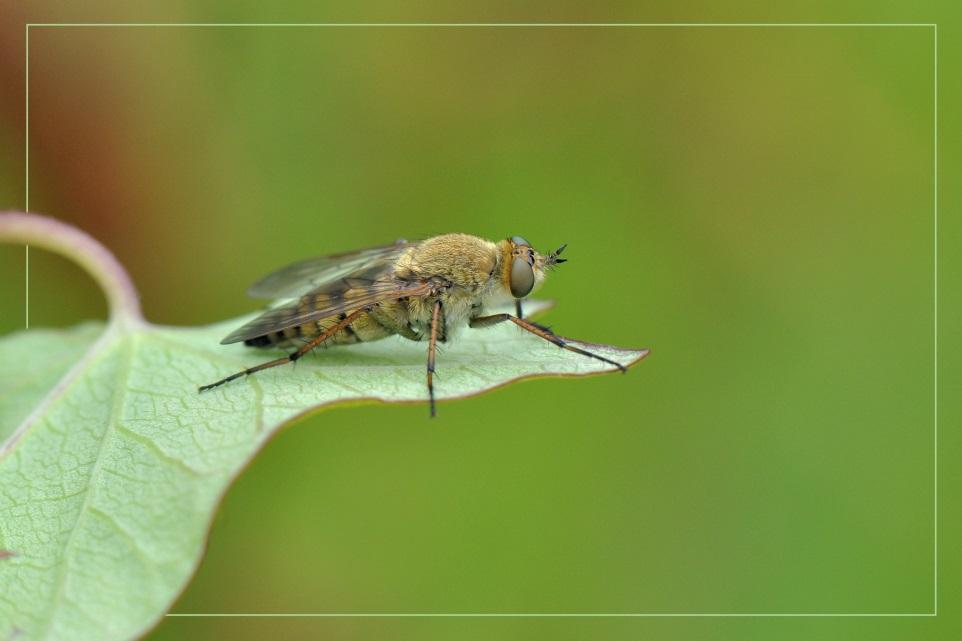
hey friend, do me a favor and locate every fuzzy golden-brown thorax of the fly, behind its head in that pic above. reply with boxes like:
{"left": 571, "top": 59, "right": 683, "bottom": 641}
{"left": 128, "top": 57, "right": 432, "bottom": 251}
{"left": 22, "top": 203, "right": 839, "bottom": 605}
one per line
{"left": 395, "top": 234, "right": 499, "bottom": 292}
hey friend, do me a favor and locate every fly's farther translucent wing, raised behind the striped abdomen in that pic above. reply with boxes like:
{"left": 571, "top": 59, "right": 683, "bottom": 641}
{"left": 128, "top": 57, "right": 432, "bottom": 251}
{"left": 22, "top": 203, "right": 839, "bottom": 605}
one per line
{"left": 247, "top": 241, "right": 416, "bottom": 299}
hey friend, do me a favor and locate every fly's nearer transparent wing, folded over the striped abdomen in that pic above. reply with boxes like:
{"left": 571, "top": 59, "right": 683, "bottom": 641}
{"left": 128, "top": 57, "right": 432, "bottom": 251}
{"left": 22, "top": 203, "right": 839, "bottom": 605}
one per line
{"left": 221, "top": 265, "right": 431, "bottom": 345}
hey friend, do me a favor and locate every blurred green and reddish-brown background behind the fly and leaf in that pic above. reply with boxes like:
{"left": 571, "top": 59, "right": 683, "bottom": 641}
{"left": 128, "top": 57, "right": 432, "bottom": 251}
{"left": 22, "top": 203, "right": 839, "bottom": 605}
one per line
{"left": 0, "top": 2, "right": 962, "bottom": 641}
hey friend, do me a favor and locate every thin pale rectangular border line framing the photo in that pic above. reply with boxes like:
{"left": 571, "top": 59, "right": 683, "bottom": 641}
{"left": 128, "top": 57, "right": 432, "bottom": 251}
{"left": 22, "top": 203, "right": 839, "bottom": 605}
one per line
{"left": 24, "top": 22, "right": 939, "bottom": 618}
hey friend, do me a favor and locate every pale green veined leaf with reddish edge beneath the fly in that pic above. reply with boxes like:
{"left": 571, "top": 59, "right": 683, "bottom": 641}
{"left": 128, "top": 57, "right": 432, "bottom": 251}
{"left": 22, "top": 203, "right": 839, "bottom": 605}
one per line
{"left": 0, "top": 215, "right": 647, "bottom": 640}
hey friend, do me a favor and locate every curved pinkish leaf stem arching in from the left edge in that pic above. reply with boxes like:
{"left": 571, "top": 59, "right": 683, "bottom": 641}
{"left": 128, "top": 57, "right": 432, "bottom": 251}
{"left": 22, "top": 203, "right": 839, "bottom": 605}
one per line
{"left": 0, "top": 211, "right": 143, "bottom": 325}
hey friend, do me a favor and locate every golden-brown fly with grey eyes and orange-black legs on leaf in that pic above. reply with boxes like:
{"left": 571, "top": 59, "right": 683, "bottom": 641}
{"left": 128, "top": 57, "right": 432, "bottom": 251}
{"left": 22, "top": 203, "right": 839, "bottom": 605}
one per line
{"left": 200, "top": 234, "right": 625, "bottom": 416}
